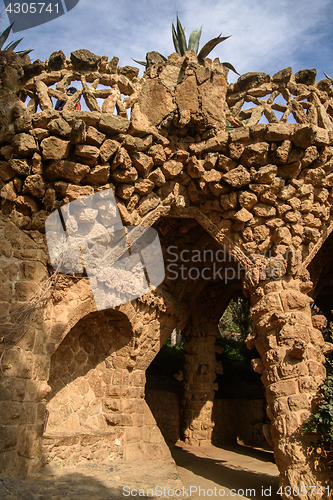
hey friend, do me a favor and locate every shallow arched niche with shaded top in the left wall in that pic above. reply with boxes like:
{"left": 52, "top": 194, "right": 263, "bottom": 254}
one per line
{"left": 44, "top": 309, "right": 133, "bottom": 464}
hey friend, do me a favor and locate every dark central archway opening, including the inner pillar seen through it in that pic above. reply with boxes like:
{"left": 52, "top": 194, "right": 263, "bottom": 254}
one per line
{"left": 146, "top": 218, "right": 268, "bottom": 454}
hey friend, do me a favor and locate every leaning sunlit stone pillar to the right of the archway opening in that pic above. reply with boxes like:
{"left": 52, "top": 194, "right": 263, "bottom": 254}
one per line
{"left": 247, "top": 276, "right": 326, "bottom": 499}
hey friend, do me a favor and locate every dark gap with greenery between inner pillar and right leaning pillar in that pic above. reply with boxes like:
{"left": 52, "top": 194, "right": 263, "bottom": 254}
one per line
{"left": 212, "top": 291, "right": 273, "bottom": 450}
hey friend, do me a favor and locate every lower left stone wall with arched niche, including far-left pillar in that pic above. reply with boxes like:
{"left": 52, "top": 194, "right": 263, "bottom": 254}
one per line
{"left": 0, "top": 212, "right": 184, "bottom": 476}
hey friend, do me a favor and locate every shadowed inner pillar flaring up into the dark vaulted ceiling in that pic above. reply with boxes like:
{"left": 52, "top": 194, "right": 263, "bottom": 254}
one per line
{"left": 149, "top": 215, "right": 246, "bottom": 445}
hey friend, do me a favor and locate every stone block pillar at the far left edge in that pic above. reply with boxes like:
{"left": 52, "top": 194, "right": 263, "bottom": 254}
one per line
{"left": 0, "top": 217, "right": 49, "bottom": 477}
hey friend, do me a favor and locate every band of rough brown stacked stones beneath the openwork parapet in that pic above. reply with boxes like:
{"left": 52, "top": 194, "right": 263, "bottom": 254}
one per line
{"left": 1, "top": 61, "right": 333, "bottom": 274}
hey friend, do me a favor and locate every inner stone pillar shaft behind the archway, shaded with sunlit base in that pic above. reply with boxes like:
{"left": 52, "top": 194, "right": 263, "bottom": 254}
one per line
{"left": 182, "top": 323, "right": 219, "bottom": 446}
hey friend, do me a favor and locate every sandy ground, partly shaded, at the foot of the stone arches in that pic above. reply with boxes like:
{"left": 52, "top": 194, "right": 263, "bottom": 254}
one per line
{"left": 24, "top": 445, "right": 280, "bottom": 500}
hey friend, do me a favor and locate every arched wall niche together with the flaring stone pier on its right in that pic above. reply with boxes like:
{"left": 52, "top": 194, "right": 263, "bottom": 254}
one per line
{"left": 44, "top": 290, "right": 186, "bottom": 464}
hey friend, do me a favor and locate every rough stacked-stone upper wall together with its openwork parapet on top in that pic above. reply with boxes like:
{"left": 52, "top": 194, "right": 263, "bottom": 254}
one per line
{"left": 0, "top": 55, "right": 333, "bottom": 280}
